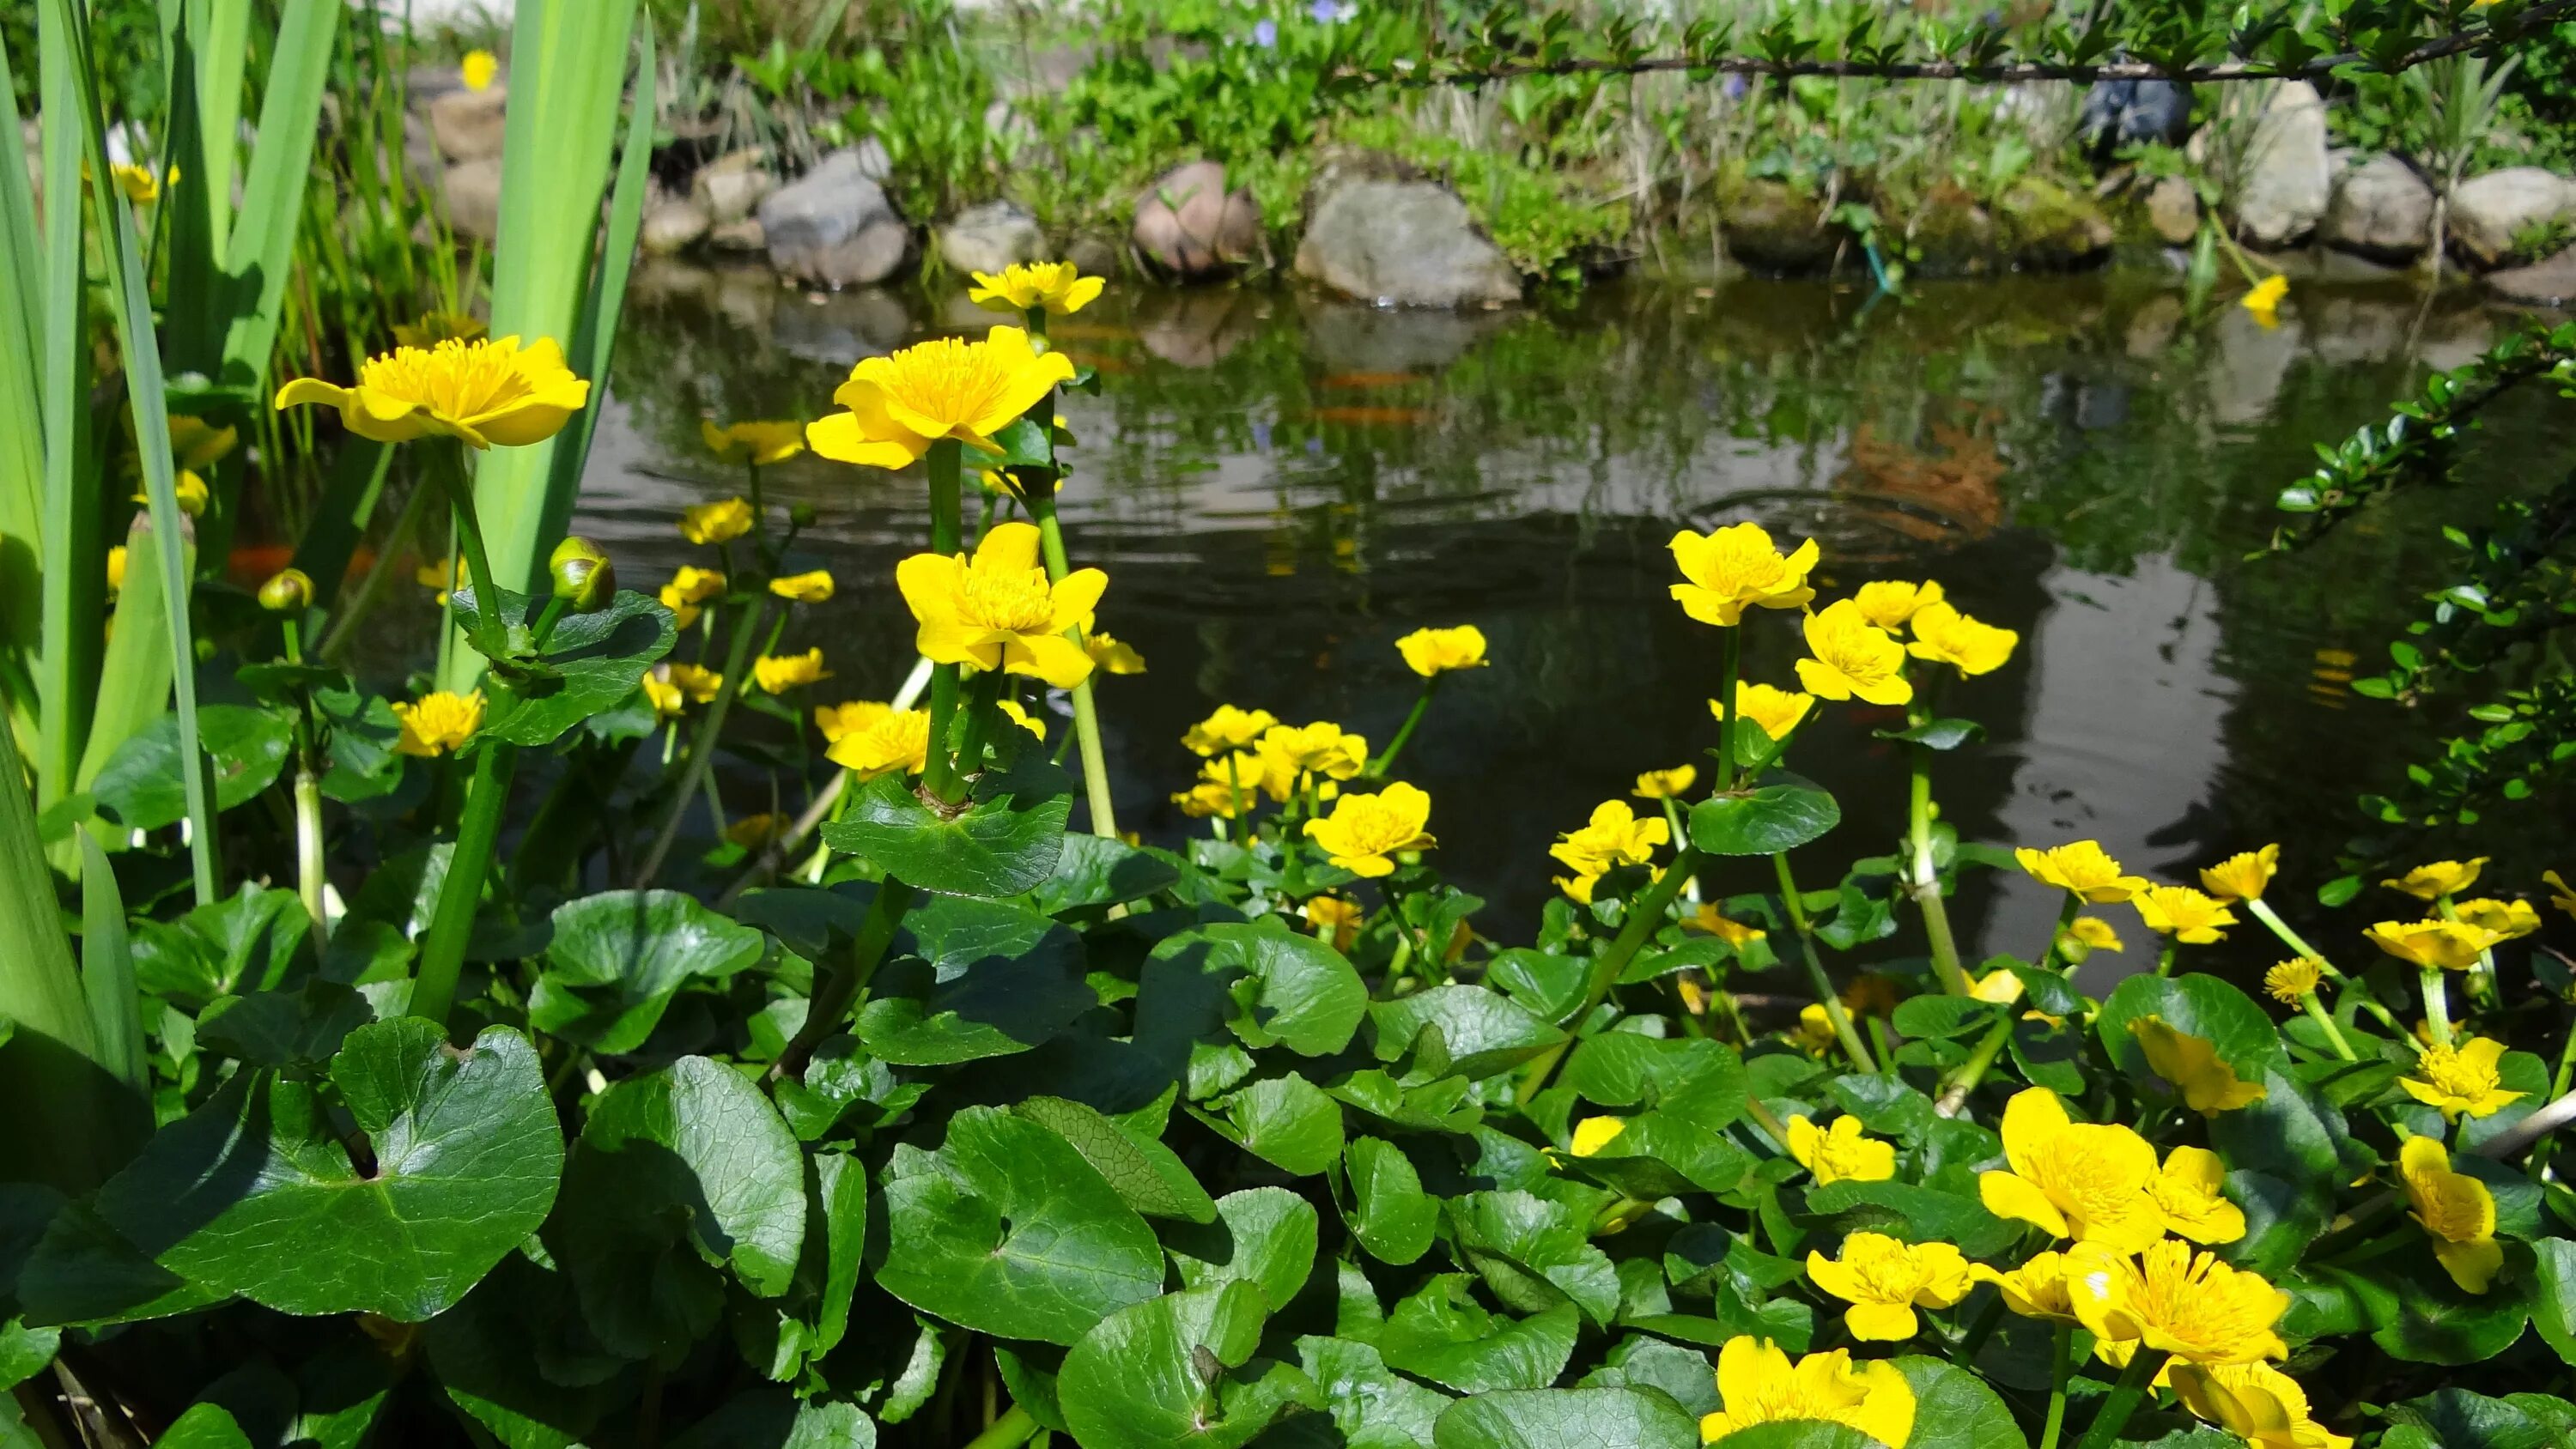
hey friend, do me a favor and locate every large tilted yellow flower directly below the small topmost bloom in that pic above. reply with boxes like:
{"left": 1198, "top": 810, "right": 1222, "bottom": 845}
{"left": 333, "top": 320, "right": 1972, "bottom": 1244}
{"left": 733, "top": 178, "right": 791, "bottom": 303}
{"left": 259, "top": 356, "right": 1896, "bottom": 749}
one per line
{"left": 806, "top": 327, "right": 1074, "bottom": 469}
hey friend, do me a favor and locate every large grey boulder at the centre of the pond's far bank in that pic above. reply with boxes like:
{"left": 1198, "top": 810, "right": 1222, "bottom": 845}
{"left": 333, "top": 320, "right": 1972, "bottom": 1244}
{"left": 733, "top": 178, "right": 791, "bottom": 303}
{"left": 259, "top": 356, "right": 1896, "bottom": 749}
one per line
{"left": 1296, "top": 180, "right": 1520, "bottom": 306}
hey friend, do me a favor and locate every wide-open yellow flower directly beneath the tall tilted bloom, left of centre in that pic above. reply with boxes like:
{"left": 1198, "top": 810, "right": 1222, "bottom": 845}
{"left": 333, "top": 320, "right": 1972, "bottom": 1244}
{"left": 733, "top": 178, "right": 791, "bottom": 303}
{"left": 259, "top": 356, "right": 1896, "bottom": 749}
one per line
{"left": 894, "top": 523, "right": 1110, "bottom": 690}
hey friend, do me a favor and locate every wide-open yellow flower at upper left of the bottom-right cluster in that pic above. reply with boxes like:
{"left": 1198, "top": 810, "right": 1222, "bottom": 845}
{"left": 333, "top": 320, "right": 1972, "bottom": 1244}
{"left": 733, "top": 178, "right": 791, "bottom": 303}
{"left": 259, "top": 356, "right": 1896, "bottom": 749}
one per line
{"left": 1976, "top": 1086, "right": 2164, "bottom": 1253}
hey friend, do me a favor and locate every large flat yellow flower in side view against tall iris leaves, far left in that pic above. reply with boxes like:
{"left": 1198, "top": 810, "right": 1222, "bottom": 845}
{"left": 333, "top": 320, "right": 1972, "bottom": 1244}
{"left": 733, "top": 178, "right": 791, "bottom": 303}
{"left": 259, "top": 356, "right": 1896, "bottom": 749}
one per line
{"left": 276, "top": 337, "right": 590, "bottom": 448}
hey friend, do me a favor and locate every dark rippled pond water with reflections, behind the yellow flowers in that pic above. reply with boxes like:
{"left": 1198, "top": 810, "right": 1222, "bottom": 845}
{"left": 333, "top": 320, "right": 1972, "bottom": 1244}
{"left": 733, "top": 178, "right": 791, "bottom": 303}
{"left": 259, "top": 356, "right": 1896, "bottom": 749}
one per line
{"left": 577, "top": 270, "right": 2568, "bottom": 988}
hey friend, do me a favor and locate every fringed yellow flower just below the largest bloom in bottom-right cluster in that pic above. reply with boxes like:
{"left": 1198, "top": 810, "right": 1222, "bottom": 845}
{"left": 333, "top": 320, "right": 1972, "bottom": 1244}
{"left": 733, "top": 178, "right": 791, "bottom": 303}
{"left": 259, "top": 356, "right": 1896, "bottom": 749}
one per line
{"left": 2066, "top": 1238, "right": 2290, "bottom": 1364}
